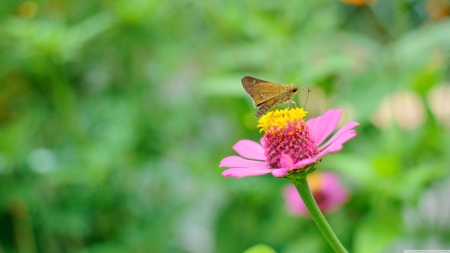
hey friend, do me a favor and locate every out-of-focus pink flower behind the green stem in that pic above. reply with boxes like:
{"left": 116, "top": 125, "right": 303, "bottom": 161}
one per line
{"left": 283, "top": 172, "right": 349, "bottom": 216}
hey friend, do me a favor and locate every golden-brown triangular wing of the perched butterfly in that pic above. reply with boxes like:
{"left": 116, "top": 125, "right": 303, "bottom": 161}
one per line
{"left": 241, "top": 76, "right": 285, "bottom": 106}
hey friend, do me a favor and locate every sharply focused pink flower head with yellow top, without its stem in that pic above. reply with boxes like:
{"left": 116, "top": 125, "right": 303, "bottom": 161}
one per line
{"left": 219, "top": 108, "right": 359, "bottom": 178}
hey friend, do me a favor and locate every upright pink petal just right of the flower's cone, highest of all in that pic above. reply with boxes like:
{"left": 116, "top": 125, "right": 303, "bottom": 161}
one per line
{"left": 306, "top": 109, "right": 342, "bottom": 146}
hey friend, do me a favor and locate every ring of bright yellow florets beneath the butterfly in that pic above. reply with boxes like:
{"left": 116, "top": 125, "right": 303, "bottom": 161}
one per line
{"left": 257, "top": 107, "right": 308, "bottom": 133}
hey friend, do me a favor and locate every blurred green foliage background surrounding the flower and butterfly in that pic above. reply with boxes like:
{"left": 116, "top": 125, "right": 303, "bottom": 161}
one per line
{"left": 0, "top": 0, "right": 450, "bottom": 253}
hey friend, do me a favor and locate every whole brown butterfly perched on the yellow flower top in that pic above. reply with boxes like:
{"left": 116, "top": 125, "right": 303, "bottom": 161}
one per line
{"left": 241, "top": 76, "right": 298, "bottom": 117}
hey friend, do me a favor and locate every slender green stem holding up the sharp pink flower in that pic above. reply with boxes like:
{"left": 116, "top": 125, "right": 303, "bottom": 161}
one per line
{"left": 289, "top": 175, "right": 347, "bottom": 253}
